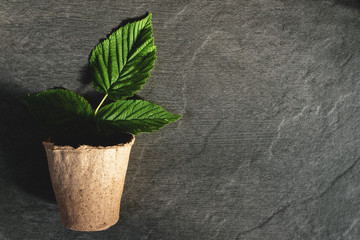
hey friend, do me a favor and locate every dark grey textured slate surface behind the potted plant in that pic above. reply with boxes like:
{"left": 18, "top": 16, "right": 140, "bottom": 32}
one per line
{"left": 0, "top": 0, "right": 360, "bottom": 240}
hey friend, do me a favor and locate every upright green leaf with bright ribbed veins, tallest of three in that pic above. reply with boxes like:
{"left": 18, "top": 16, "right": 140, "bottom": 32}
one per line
{"left": 90, "top": 13, "right": 156, "bottom": 100}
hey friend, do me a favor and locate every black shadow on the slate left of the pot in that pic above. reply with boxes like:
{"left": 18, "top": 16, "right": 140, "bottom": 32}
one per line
{"left": 0, "top": 79, "right": 55, "bottom": 202}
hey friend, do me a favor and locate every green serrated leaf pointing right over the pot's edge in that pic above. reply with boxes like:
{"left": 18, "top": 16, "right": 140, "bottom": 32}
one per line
{"left": 96, "top": 100, "right": 181, "bottom": 135}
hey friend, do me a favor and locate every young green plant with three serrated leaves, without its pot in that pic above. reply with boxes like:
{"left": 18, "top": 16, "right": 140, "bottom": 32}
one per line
{"left": 24, "top": 14, "right": 181, "bottom": 142}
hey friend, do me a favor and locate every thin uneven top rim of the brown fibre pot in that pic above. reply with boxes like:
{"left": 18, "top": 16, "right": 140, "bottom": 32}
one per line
{"left": 42, "top": 134, "right": 135, "bottom": 150}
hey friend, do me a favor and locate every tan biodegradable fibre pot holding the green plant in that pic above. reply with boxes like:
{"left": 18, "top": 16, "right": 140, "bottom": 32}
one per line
{"left": 43, "top": 136, "right": 135, "bottom": 231}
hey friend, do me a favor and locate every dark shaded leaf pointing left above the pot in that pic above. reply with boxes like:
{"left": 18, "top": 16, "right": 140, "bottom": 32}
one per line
{"left": 23, "top": 89, "right": 93, "bottom": 134}
